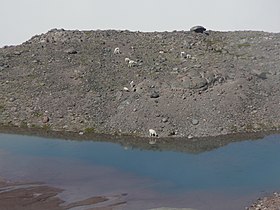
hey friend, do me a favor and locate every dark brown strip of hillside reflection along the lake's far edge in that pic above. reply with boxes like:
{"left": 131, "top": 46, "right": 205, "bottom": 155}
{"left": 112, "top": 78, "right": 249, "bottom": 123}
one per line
{"left": 0, "top": 126, "right": 279, "bottom": 153}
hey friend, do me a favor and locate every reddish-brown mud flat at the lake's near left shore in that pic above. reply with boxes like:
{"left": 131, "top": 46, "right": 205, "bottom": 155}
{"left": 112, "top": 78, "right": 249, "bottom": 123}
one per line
{"left": 0, "top": 179, "right": 124, "bottom": 210}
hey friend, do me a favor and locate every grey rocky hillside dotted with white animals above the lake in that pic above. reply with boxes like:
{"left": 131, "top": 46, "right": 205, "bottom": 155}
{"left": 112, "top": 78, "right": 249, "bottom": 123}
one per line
{"left": 0, "top": 29, "right": 280, "bottom": 138}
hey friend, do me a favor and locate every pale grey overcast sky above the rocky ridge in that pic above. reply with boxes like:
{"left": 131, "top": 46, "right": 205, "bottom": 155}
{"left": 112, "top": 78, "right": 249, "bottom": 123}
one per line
{"left": 0, "top": 0, "right": 280, "bottom": 47}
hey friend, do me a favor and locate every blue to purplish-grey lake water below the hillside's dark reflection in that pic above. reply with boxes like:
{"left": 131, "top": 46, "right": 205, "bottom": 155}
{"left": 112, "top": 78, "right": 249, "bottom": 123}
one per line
{"left": 0, "top": 134, "right": 280, "bottom": 210}
